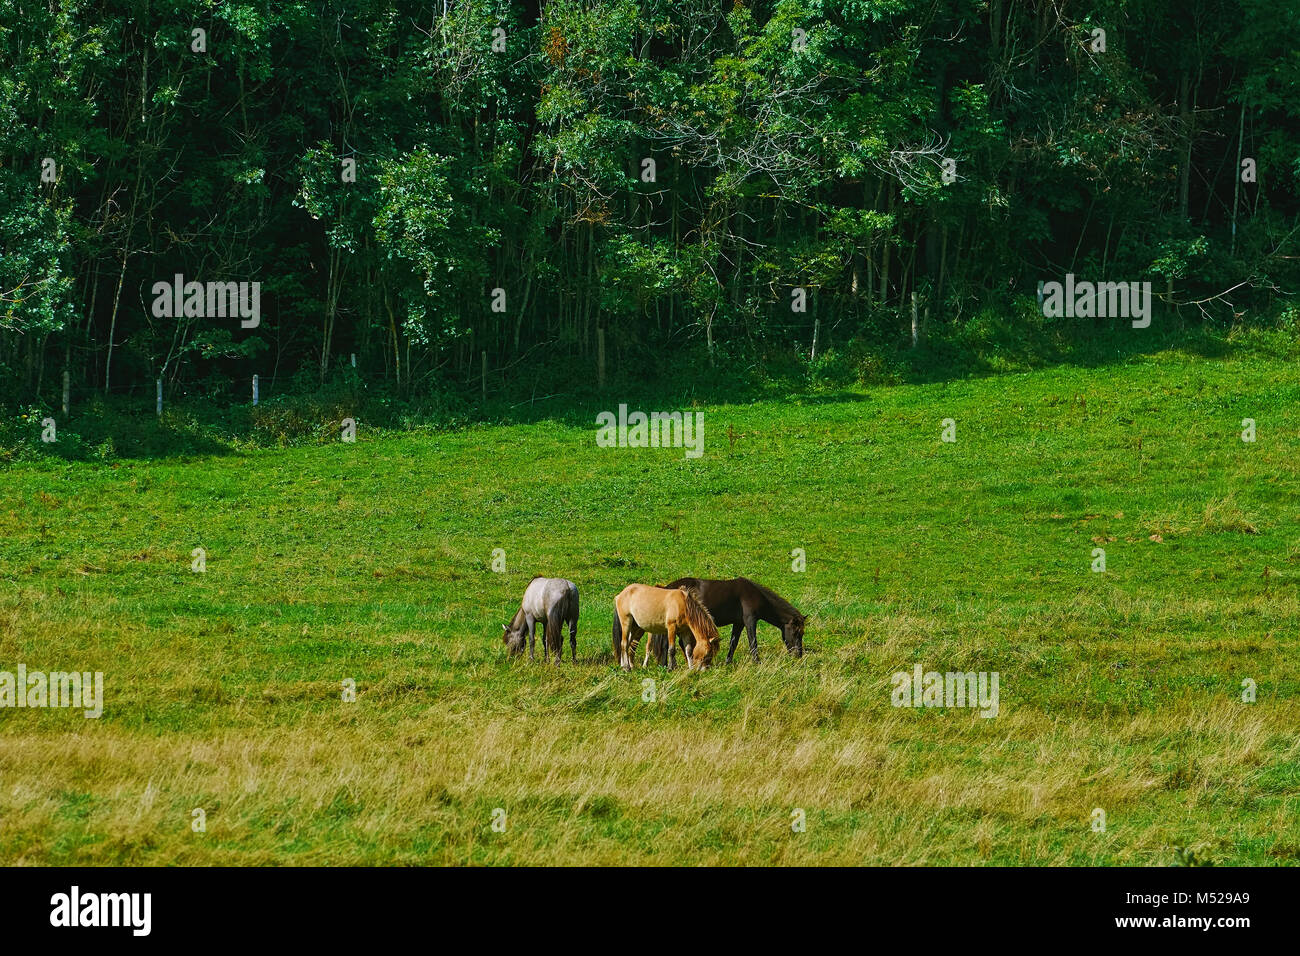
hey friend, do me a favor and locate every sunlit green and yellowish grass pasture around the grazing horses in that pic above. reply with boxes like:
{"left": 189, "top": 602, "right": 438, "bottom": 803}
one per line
{"left": 0, "top": 351, "right": 1300, "bottom": 865}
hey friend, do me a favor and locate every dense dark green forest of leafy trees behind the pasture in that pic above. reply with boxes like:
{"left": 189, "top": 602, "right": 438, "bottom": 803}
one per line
{"left": 0, "top": 0, "right": 1300, "bottom": 411}
